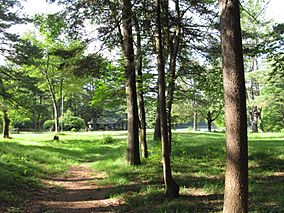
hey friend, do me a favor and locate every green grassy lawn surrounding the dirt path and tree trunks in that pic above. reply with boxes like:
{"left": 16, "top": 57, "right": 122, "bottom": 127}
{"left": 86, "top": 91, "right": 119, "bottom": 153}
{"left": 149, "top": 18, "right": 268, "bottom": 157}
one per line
{"left": 0, "top": 132, "right": 284, "bottom": 212}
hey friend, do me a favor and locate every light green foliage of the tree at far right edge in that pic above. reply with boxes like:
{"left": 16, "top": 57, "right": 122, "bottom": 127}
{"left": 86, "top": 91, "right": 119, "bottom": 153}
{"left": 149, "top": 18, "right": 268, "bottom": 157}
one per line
{"left": 258, "top": 24, "right": 284, "bottom": 131}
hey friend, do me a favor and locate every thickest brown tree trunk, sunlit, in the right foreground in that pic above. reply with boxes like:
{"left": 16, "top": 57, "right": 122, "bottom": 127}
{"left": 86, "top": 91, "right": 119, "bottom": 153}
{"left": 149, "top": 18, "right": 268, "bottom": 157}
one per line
{"left": 219, "top": 0, "right": 248, "bottom": 213}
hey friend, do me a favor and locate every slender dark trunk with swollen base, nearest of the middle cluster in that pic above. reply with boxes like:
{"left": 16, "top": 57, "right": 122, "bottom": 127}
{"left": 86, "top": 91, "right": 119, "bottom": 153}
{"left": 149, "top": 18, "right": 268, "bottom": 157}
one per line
{"left": 156, "top": 0, "right": 179, "bottom": 198}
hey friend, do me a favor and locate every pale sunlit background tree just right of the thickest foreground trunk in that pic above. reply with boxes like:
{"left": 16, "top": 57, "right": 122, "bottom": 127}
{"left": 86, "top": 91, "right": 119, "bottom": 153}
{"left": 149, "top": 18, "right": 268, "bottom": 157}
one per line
{"left": 241, "top": 0, "right": 271, "bottom": 132}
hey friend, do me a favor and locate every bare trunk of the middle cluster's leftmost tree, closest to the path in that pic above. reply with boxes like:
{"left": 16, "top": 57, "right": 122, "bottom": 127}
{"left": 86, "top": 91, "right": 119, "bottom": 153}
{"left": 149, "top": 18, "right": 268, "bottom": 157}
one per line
{"left": 122, "top": 0, "right": 141, "bottom": 165}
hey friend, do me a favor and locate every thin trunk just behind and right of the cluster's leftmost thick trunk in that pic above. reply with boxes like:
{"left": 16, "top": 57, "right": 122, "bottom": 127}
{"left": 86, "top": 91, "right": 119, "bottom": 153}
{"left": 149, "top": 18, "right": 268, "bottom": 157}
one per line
{"left": 134, "top": 16, "right": 148, "bottom": 158}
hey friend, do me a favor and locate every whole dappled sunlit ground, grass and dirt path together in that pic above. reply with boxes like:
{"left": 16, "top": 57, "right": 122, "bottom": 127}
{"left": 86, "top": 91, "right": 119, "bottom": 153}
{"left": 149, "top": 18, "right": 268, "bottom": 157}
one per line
{"left": 0, "top": 131, "right": 284, "bottom": 212}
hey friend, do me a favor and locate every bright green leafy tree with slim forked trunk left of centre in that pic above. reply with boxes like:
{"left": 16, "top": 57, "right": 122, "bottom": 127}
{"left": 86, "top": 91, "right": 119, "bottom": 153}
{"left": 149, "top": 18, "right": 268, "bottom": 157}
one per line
{"left": 10, "top": 14, "right": 87, "bottom": 132}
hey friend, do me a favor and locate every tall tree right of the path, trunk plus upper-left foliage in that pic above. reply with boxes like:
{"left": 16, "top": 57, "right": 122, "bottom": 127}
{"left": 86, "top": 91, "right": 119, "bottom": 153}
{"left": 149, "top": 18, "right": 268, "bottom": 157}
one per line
{"left": 52, "top": 0, "right": 143, "bottom": 165}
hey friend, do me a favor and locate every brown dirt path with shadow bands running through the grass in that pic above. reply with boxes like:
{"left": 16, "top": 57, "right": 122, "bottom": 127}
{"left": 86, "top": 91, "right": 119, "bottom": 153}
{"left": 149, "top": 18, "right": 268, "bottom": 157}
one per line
{"left": 25, "top": 164, "right": 122, "bottom": 213}
